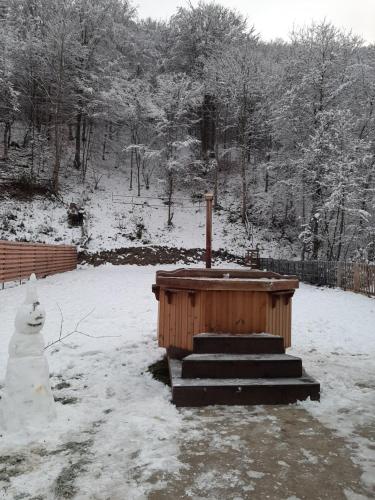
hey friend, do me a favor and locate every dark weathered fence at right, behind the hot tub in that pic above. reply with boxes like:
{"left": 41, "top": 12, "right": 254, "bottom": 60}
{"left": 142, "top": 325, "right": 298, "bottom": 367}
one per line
{"left": 260, "top": 259, "right": 375, "bottom": 295}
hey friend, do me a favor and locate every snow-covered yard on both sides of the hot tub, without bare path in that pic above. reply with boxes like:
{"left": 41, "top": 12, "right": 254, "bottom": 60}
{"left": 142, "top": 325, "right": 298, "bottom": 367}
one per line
{"left": 0, "top": 265, "right": 375, "bottom": 500}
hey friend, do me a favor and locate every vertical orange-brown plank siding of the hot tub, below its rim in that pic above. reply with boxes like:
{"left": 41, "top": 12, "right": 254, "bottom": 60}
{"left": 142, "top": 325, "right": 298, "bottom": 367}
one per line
{"left": 158, "top": 290, "right": 291, "bottom": 350}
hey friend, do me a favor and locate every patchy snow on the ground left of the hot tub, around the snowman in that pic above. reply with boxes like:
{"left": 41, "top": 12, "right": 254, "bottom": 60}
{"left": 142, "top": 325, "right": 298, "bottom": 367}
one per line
{"left": 0, "top": 266, "right": 181, "bottom": 498}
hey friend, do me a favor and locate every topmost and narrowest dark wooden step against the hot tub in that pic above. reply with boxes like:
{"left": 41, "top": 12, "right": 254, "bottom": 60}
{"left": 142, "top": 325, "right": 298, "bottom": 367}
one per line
{"left": 193, "top": 333, "right": 285, "bottom": 354}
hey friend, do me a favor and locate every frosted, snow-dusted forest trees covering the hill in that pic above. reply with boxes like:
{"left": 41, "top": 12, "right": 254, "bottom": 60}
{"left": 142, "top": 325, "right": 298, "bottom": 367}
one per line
{"left": 0, "top": 0, "right": 375, "bottom": 262}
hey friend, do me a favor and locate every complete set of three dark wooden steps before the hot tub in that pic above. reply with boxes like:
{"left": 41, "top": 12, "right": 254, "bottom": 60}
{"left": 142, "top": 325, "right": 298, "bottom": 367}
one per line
{"left": 168, "top": 334, "right": 320, "bottom": 406}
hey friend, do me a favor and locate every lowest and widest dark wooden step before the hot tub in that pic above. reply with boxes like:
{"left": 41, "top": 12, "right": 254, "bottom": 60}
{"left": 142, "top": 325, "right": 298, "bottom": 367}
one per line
{"left": 168, "top": 358, "right": 320, "bottom": 407}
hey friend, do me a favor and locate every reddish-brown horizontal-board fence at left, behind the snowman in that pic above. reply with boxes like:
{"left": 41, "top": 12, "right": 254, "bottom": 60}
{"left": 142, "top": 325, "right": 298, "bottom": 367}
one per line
{"left": 0, "top": 240, "right": 77, "bottom": 286}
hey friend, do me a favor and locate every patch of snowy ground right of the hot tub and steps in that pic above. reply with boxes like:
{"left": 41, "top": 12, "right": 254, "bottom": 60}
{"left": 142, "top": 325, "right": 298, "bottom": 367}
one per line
{"left": 289, "top": 285, "right": 375, "bottom": 488}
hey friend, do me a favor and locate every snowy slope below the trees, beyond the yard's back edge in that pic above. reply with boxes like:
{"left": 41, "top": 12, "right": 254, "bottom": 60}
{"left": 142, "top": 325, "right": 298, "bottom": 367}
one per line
{"left": 0, "top": 164, "right": 297, "bottom": 257}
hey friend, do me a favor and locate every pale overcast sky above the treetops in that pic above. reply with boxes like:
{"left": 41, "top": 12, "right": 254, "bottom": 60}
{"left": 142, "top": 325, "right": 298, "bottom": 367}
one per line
{"left": 135, "top": 0, "right": 375, "bottom": 43}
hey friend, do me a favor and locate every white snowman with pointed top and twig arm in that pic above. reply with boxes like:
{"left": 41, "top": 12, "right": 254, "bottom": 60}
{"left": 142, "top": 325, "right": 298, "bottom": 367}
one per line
{"left": 2, "top": 274, "right": 56, "bottom": 431}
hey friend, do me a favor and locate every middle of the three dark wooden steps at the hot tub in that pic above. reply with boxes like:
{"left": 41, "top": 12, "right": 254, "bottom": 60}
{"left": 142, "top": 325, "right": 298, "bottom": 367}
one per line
{"left": 182, "top": 353, "right": 302, "bottom": 378}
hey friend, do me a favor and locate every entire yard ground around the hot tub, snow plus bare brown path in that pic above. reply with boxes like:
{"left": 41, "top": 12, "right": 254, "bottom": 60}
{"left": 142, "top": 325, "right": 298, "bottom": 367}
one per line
{"left": 0, "top": 265, "right": 375, "bottom": 500}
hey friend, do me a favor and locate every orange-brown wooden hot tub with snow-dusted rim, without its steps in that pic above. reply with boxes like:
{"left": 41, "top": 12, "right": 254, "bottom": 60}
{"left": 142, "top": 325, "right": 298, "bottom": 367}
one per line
{"left": 152, "top": 269, "right": 298, "bottom": 352}
